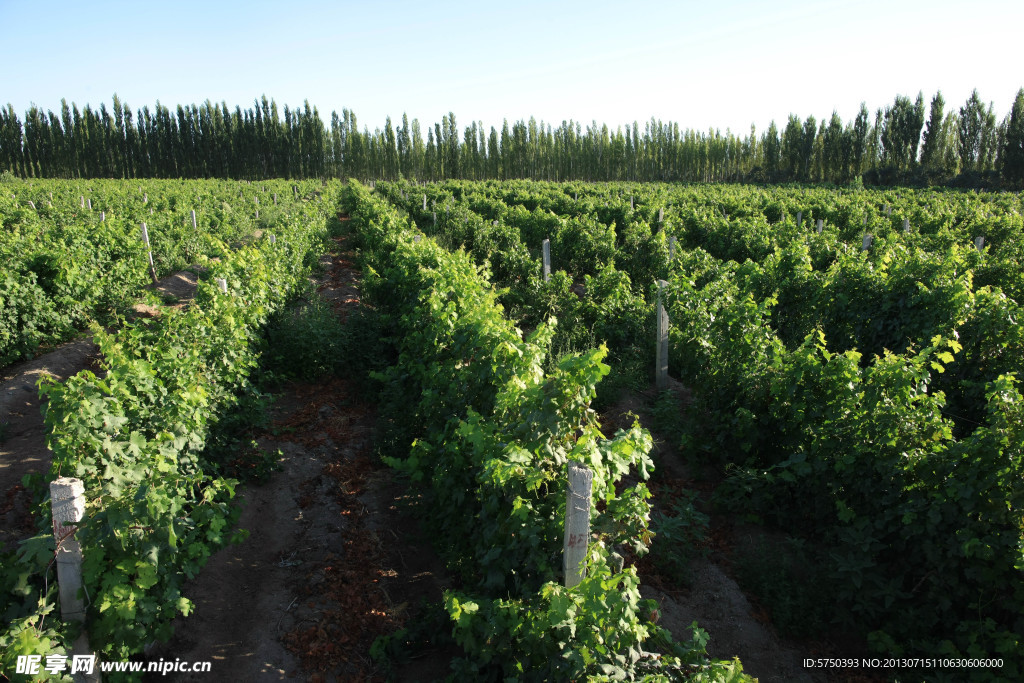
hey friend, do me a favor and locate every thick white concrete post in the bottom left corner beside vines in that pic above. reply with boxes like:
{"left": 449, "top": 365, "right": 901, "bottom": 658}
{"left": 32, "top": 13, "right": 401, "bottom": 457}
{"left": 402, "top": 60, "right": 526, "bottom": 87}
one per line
{"left": 50, "top": 477, "right": 100, "bottom": 683}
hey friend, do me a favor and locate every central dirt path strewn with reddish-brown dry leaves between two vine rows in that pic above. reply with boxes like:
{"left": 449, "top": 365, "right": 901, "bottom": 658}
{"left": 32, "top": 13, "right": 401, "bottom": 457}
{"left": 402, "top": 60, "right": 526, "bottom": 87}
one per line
{"left": 147, "top": 233, "right": 447, "bottom": 682}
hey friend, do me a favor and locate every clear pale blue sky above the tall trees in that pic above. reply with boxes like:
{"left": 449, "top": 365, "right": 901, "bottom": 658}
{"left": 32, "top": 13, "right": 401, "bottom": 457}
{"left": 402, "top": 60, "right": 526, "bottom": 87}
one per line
{"left": 0, "top": 0, "right": 1024, "bottom": 134}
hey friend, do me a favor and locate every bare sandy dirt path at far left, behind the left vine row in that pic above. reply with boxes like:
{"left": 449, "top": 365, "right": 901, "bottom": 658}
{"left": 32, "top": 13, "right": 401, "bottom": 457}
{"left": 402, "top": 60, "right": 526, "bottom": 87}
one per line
{"left": 0, "top": 270, "right": 197, "bottom": 546}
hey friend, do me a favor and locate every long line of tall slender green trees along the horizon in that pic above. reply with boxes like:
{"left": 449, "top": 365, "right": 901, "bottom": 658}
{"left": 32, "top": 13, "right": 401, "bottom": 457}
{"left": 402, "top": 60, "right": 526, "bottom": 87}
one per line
{"left": 0, "top": 88, "right": 1024, "bottom": 188}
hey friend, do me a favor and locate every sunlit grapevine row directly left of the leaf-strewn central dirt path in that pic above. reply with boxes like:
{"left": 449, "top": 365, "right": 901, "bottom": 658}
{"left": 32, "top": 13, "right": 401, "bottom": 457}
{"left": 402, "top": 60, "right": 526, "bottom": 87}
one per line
{"left": 0, "top": 181, "right": 335, "bottom": 673}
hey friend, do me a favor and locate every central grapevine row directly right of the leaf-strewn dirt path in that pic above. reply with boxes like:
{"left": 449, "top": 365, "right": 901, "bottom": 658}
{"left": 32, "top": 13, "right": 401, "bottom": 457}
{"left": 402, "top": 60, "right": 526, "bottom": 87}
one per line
{"left": 345, "top": 182, "right": 749, "bottom": 681}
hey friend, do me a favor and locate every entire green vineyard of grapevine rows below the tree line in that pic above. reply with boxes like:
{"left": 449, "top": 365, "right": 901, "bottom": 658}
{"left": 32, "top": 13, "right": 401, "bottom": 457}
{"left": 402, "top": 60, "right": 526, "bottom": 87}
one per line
{"left": 0, "top": 180, "right": 1024, "bottom": 681}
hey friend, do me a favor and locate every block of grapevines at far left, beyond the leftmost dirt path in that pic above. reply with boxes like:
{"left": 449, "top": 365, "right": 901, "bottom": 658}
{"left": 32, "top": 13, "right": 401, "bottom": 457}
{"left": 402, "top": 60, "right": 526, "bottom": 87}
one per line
{"left": 0, "top": 180, "right": 319, "bottom": 367}
